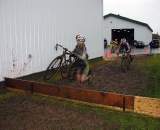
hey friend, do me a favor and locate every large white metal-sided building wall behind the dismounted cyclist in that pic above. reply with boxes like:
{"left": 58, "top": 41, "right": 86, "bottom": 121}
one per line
{"left": 0, "top": 0, "right": 103, "bottom": 81}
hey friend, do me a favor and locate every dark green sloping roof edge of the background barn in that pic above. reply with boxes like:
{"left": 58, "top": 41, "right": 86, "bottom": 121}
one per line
{"left": 104, "top": 13, "right": 153, "bottom": 32}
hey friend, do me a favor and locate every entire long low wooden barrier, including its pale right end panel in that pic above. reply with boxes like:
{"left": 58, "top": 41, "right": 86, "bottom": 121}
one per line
{"left": 5, "top": 78, "right": 160, "bottom": 117}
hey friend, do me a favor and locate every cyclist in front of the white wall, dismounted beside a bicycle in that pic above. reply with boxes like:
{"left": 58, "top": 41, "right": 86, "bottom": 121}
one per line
{"left": 73, "top": 35, "right": 89, "bottom": 83}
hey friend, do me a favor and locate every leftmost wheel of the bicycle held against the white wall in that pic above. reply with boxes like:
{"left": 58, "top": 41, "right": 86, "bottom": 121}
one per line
{"left": 43, "top": 56, "right": 62, "bottom": 80}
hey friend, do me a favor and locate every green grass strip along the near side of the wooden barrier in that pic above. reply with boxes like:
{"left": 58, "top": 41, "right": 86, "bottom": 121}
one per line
{"left": 0, "top": 92, "right": 160, "bottom": 130}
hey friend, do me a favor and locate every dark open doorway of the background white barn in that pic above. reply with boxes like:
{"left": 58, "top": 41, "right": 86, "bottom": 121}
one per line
{"left": 112, "top": 29, "right": 134, "bottom": 45}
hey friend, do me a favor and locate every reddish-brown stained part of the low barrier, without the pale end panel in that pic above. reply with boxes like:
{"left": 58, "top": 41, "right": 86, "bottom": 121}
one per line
{"left": 5, "top": 78, "right": 134, "bottom": 111}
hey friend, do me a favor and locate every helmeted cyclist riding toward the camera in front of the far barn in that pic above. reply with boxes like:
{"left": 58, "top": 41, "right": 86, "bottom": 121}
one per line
{"left": 117, "top": 38, "right": 133, "bottom": 61}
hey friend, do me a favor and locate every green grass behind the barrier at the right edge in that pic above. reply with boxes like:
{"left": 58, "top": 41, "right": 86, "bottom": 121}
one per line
{"left": 136, "top": 55, "right": 160, "bottom": 98}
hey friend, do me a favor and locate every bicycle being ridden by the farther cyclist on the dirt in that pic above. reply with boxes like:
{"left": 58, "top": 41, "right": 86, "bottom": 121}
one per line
{"left": 121, "top": 49, "right": 133, "bottom": 72}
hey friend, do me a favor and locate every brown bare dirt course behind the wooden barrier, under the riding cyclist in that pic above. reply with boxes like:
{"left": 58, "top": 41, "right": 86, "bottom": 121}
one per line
{"left": 56, "top": 58, "right": 147, "bottom": 95}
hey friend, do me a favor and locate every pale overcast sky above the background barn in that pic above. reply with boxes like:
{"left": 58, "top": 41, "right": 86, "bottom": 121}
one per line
{"left": 103, "top": 0, "right": 160, "bottom": 34}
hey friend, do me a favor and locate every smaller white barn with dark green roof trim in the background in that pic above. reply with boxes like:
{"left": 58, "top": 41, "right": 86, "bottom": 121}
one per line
{"left": 104, "top": 14, "right": 153, "bottom": 45}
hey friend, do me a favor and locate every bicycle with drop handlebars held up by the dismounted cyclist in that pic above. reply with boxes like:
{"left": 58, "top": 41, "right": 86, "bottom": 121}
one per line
{"left": 43, "top": 44, "right": 78, "bottom": 80}
